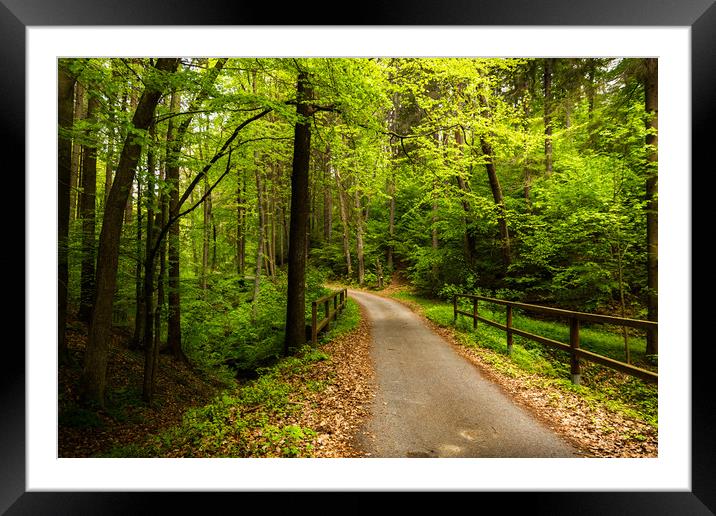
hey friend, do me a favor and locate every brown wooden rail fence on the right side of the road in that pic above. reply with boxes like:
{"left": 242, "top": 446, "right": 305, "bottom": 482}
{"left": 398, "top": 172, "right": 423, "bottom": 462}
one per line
{"left": 453, "top": 294, "right": 659, "bottom": 384}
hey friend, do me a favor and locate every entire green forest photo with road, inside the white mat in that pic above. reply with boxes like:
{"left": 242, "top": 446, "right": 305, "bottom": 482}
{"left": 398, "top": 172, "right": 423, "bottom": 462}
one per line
{"left": 57, "top": 57, "right": 658, "bottom": 458}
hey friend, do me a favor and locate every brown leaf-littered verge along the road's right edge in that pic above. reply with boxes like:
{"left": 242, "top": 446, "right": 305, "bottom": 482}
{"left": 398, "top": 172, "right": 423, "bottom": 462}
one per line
{"left": 370, "top": 277, "right": 658, "bottom": 458}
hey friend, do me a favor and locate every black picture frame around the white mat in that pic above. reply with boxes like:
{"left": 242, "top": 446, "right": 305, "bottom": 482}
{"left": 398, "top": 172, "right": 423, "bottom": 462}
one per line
{"left": 7, "top": 0, "right": 716, "bottom": 515}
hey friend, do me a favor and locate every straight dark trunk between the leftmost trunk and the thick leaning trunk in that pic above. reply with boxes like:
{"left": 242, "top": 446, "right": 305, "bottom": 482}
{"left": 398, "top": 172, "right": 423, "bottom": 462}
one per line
{"left": 79, "top": 90, "right": 99, "bottom": 322}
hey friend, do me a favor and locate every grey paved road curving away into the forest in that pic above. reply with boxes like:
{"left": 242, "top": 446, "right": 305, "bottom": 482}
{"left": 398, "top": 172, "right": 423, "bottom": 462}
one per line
{"left": 349, "top": 290, "right": 577, "bottom": 457}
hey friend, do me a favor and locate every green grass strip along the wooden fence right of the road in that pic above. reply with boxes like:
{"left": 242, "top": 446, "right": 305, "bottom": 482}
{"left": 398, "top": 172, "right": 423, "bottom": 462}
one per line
{"left": 392, "top": 292, "right": 658, "bottom": 428}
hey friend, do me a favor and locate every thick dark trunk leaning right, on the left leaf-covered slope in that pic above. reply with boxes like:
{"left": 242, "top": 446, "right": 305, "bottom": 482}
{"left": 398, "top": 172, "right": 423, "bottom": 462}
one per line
{"left": 80, "top": 58, "right": 179, "bottom": 406}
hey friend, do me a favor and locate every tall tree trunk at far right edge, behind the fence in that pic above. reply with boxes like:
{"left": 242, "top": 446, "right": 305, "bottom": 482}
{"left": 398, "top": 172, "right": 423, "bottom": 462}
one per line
{"left": 644, "top": 58, "right": 659, "bottom": 355}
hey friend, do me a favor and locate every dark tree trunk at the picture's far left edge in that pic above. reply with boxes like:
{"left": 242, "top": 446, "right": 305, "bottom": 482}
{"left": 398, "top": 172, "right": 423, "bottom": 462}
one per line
{"left": 57, "top": 59, "right": 76, "bottom": 362}
